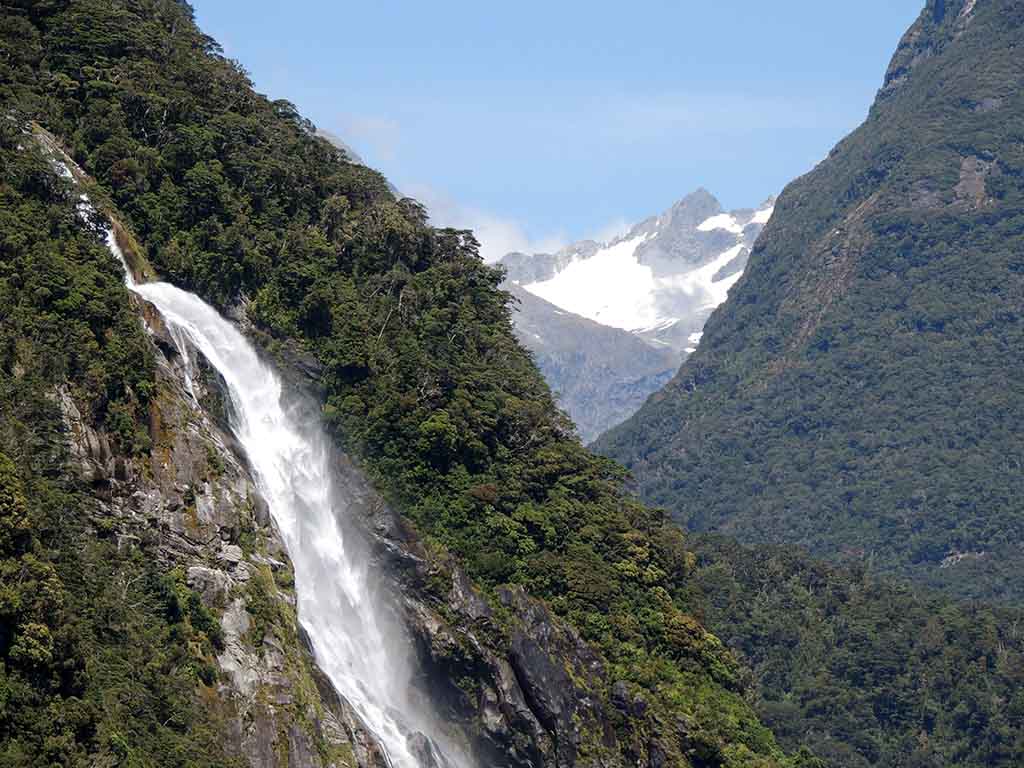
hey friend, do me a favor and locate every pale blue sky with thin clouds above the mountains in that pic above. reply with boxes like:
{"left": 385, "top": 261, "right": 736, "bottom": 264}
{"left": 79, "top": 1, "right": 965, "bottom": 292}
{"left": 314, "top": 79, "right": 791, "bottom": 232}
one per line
{"left": 193, "top": 0, "right": 924, "bottom": 258}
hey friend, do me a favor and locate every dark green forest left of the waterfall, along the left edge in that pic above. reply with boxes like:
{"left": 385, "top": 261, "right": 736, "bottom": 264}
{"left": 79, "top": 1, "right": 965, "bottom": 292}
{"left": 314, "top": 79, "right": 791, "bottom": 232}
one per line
{"left": 0, "top": 120, "right": 232, "bottom": 768}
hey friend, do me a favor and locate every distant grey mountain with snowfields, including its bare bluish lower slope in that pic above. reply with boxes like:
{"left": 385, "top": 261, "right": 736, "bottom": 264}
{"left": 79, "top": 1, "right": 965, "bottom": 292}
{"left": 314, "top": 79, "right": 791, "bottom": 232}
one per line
{"left": 501, "top": 189, "right": 773, "bottom": 441}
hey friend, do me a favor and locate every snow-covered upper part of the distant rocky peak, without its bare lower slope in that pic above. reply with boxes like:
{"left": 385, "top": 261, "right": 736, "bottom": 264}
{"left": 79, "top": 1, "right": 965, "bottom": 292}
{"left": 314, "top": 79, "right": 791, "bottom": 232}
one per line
{"left": 502, "top": 189, "right": 773, "bottom": 352}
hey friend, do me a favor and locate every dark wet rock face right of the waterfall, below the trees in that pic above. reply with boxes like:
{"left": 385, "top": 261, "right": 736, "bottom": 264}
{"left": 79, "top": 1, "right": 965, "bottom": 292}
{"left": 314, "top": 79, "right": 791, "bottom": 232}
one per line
{"left": 323, "top": 461, "right": 626, "bottom": 768}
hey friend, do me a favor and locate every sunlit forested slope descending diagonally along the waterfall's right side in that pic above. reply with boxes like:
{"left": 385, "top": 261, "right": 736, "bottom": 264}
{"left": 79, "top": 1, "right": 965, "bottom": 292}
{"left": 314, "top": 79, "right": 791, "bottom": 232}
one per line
{"left": 0, "top": 0, "right": 790, "bottom": 766}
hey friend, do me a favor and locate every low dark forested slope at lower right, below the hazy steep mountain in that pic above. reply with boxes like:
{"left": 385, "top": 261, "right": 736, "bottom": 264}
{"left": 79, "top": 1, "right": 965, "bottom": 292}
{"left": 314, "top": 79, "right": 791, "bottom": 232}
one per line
{"left": 687, "top": 536, "right": 1024, "bottom": 768}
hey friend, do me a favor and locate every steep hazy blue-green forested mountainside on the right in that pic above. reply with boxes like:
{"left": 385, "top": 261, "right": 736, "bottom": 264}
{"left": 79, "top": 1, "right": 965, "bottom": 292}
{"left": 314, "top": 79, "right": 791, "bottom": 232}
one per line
{"left": 598, "top": 0, "right": 1024, "bottom": 599}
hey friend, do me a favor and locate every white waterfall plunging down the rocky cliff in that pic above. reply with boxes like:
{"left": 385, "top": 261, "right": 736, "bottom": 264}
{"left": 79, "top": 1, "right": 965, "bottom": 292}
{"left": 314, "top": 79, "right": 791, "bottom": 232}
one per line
{"left": 108, "top": 234, "right": 466, "bottom": 768}
